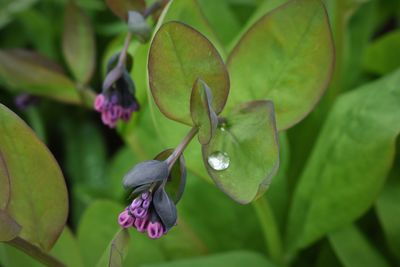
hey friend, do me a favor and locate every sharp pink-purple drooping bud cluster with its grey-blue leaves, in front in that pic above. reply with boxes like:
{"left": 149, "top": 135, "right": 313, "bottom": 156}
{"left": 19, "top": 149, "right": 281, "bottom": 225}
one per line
{"left": 118, "top": 160, "right": 177, "bottom": 239}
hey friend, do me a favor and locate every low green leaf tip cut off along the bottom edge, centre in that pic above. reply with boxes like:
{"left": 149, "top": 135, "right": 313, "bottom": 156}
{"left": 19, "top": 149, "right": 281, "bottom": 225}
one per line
{"left": 144, "top": 251, "right": 274, "bottom": 267}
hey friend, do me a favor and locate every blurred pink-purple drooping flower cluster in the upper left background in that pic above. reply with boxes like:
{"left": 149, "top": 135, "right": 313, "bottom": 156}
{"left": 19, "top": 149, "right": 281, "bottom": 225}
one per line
{"left": 94, "top": 70, "right": 139, "bottom": 128}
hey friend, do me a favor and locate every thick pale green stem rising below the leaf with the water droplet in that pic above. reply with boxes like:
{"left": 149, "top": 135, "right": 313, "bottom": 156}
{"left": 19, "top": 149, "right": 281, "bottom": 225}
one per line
{"left": 253, "top": 197, "right": 285, "bottom": 266}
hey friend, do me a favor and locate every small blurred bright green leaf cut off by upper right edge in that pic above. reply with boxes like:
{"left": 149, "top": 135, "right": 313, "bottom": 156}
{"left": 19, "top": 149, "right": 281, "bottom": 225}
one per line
{"left": 363, "top": 30, "right": 400, "bottom": 75}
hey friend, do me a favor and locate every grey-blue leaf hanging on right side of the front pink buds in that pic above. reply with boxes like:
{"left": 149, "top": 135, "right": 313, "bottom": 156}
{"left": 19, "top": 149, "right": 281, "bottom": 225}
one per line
{"left": 153, "top": 186, "right": 178, "bottom": 231}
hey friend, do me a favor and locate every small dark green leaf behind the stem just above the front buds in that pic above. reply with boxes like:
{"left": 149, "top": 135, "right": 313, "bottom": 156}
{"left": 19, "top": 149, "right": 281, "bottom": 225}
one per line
{"left": 155, "top": 148, "right": 186, "bottom": 204}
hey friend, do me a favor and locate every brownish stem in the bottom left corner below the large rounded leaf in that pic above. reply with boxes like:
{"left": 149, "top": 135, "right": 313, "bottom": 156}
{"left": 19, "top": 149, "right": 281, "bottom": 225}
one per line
{"left": 7, "top": 237, "right": 66, "bottom": 267}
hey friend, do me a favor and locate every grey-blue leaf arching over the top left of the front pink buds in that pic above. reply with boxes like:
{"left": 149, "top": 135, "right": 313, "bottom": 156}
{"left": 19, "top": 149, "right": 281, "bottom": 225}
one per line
{"left": 123, "top": 160, "right": 168, "bottom": 188}
